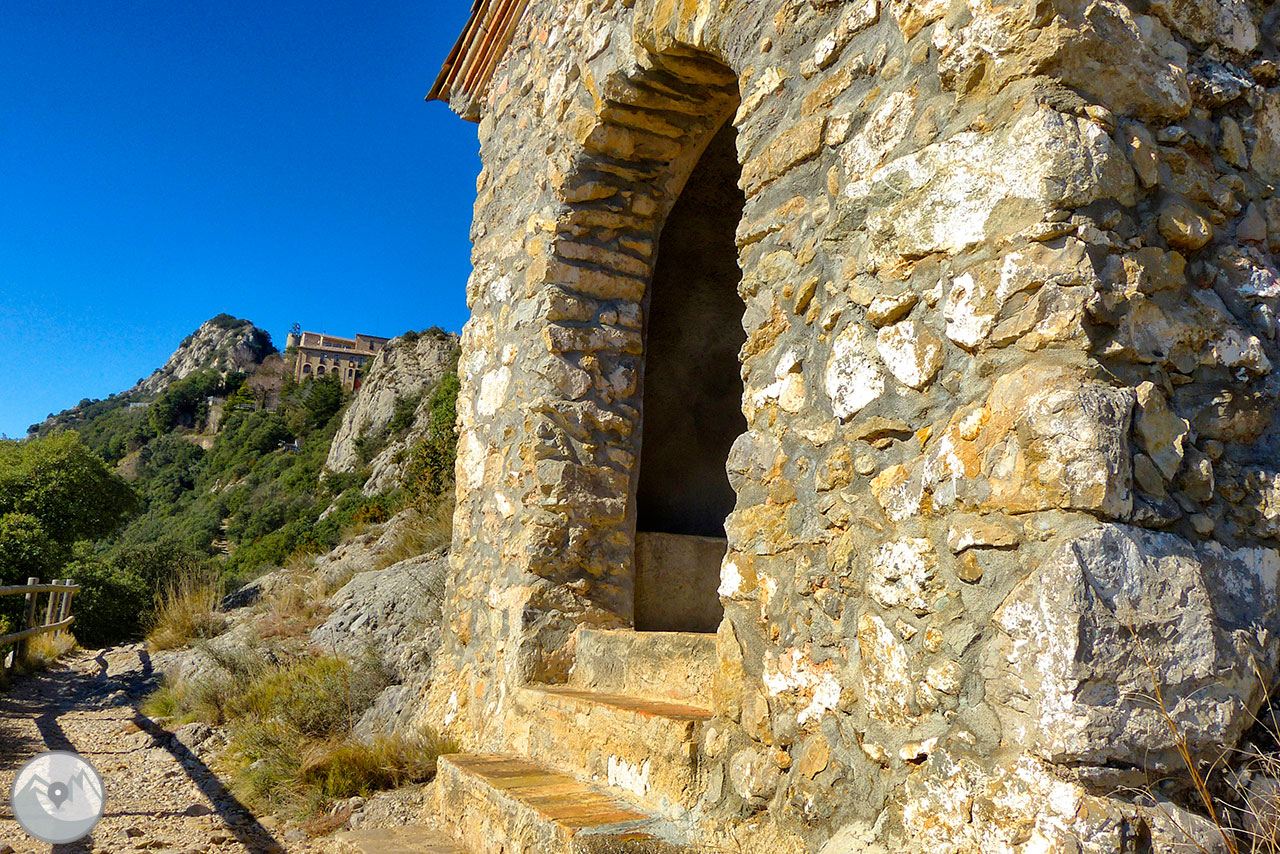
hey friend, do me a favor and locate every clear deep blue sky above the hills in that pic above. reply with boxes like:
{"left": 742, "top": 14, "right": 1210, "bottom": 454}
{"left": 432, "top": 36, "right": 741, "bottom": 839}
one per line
{"left": 0, "top": 0, "right": 480, "bottom": 437}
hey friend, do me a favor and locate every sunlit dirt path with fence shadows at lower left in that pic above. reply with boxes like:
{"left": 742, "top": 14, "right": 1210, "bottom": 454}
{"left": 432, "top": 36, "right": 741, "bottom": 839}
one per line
{"left": 0, "top": 644, "right": 314, "bottom": 854}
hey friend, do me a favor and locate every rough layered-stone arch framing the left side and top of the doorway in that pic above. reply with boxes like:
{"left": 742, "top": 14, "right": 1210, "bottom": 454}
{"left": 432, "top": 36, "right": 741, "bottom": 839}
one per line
{"left": 529, "top": 46, "right": 745, "bottom": 647}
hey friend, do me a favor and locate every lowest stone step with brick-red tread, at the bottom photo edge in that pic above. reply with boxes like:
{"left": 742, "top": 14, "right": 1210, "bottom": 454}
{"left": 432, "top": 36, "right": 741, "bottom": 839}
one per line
{"left": 436, "top": 753, "right": 671, "bottom": 854}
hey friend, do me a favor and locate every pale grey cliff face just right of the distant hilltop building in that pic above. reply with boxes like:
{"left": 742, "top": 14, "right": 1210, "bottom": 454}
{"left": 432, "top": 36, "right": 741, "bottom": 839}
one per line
{"left": 325, "top": 333, "right": 458, "bottom": 493}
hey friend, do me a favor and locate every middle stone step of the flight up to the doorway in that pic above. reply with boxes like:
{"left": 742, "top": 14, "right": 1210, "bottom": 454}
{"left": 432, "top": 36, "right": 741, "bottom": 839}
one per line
{"left": 515, "top": 685, "right": 712, "bottom": 818}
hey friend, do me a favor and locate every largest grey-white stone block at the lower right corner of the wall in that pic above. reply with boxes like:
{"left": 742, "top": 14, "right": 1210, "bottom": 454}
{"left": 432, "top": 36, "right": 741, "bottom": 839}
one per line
{"left": 988, "top": 524, "right": 1280, "bottom": 767}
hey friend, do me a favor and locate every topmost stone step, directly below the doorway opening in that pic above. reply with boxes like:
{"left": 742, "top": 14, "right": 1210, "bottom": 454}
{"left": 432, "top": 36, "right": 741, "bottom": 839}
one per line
{"left": 568, "top": 629, "right": 716, "bottom": 708}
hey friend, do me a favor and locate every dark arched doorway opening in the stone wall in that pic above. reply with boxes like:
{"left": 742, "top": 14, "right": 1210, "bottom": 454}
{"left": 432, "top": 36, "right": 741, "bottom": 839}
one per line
{"left": 635, "top": 122, "right": 746, "bottom": 631}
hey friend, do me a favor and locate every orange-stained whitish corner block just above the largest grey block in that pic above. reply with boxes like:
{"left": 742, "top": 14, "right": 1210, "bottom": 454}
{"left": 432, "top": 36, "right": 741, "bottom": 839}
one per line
{"left": 922, "top": 365, "right": 1134, "bottom": 519}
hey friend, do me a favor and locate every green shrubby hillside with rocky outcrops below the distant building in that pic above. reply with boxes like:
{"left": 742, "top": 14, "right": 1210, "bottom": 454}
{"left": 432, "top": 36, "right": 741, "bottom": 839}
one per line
{"left": 0, "top": 315, "right": 457, "bottom": 647}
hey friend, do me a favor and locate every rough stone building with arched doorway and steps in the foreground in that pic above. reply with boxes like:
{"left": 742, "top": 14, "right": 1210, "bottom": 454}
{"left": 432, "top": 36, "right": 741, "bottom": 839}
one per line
{"left": 421, "top": 0, "right": 1280, "bottom": 854}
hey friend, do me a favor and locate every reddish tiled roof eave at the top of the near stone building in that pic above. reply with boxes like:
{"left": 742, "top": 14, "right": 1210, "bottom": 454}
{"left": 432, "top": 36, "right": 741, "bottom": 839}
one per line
{"left": 426, "top": 0, "right": 529, "bottom": 122}
